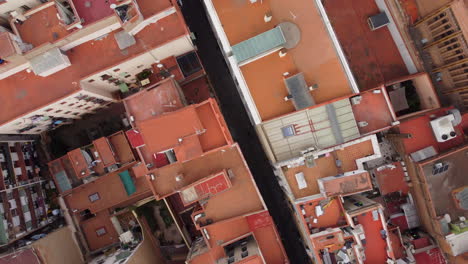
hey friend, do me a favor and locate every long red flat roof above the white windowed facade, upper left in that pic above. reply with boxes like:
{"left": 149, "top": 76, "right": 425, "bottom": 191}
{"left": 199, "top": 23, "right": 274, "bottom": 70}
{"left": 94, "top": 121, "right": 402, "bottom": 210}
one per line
{"left": 0, "top": 14, "right": 186, "bottom": 124}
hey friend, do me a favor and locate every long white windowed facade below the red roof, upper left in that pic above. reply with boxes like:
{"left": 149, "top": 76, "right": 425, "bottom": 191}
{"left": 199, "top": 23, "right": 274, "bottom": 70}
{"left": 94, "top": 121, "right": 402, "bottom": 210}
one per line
{"left": 0, "top": 32, "right": 194, "bottom": 134}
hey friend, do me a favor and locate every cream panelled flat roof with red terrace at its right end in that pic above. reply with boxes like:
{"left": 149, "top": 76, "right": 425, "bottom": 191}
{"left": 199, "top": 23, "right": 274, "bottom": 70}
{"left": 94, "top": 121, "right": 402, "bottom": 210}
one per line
{"left": 260, "top": 87, "right": 396, "bottom": 163}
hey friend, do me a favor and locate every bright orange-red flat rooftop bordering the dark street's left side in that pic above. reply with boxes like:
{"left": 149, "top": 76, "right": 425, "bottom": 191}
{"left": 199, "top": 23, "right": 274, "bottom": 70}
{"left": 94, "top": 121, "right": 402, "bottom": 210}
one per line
{"left": 132, "top": 99, "right": 232, "bottom": 167}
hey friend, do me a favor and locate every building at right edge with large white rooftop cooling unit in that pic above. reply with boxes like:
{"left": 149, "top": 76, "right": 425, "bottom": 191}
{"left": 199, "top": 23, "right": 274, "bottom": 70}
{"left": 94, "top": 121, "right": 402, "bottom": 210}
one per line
{"left": 395, "top": 107, "right": 467, "bottom": 263}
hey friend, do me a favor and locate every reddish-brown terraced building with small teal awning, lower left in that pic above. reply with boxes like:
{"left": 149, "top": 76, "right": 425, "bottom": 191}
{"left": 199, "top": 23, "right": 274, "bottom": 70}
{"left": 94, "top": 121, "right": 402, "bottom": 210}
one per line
{"left": 49, "top": 131, "right": 157, "bottom": 252}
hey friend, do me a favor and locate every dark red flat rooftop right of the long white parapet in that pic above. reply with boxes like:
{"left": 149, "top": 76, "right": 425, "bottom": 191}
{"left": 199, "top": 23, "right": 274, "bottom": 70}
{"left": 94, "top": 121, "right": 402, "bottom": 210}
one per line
{"left": 324, "top": 0, "right": 408, "bottom": 90}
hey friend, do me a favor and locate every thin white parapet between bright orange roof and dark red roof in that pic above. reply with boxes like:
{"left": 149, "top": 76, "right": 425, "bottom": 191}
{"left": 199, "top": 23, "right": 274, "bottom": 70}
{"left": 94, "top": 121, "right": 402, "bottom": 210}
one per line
{"left": 315, "top": 0, "right": 359, "bottom": 93}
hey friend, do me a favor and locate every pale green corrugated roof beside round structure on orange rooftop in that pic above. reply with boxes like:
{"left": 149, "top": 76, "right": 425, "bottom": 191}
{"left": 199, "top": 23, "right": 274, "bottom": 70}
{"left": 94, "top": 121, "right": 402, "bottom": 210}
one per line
{"left": 232, "top": 27, "right": 286, "bottom": 63}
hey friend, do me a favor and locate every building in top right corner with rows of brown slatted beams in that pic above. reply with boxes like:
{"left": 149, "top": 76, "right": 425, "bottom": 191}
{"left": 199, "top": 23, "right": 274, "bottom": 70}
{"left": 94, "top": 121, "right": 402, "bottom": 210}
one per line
{"left": 414, "top": 1, "right": 468, "bottom": 107}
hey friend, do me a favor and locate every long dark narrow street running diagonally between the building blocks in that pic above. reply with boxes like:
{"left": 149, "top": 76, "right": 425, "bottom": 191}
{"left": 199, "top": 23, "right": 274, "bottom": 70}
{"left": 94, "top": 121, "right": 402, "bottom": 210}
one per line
{"left": 182, "top": 0, "right": 311, "bottom": 264}
